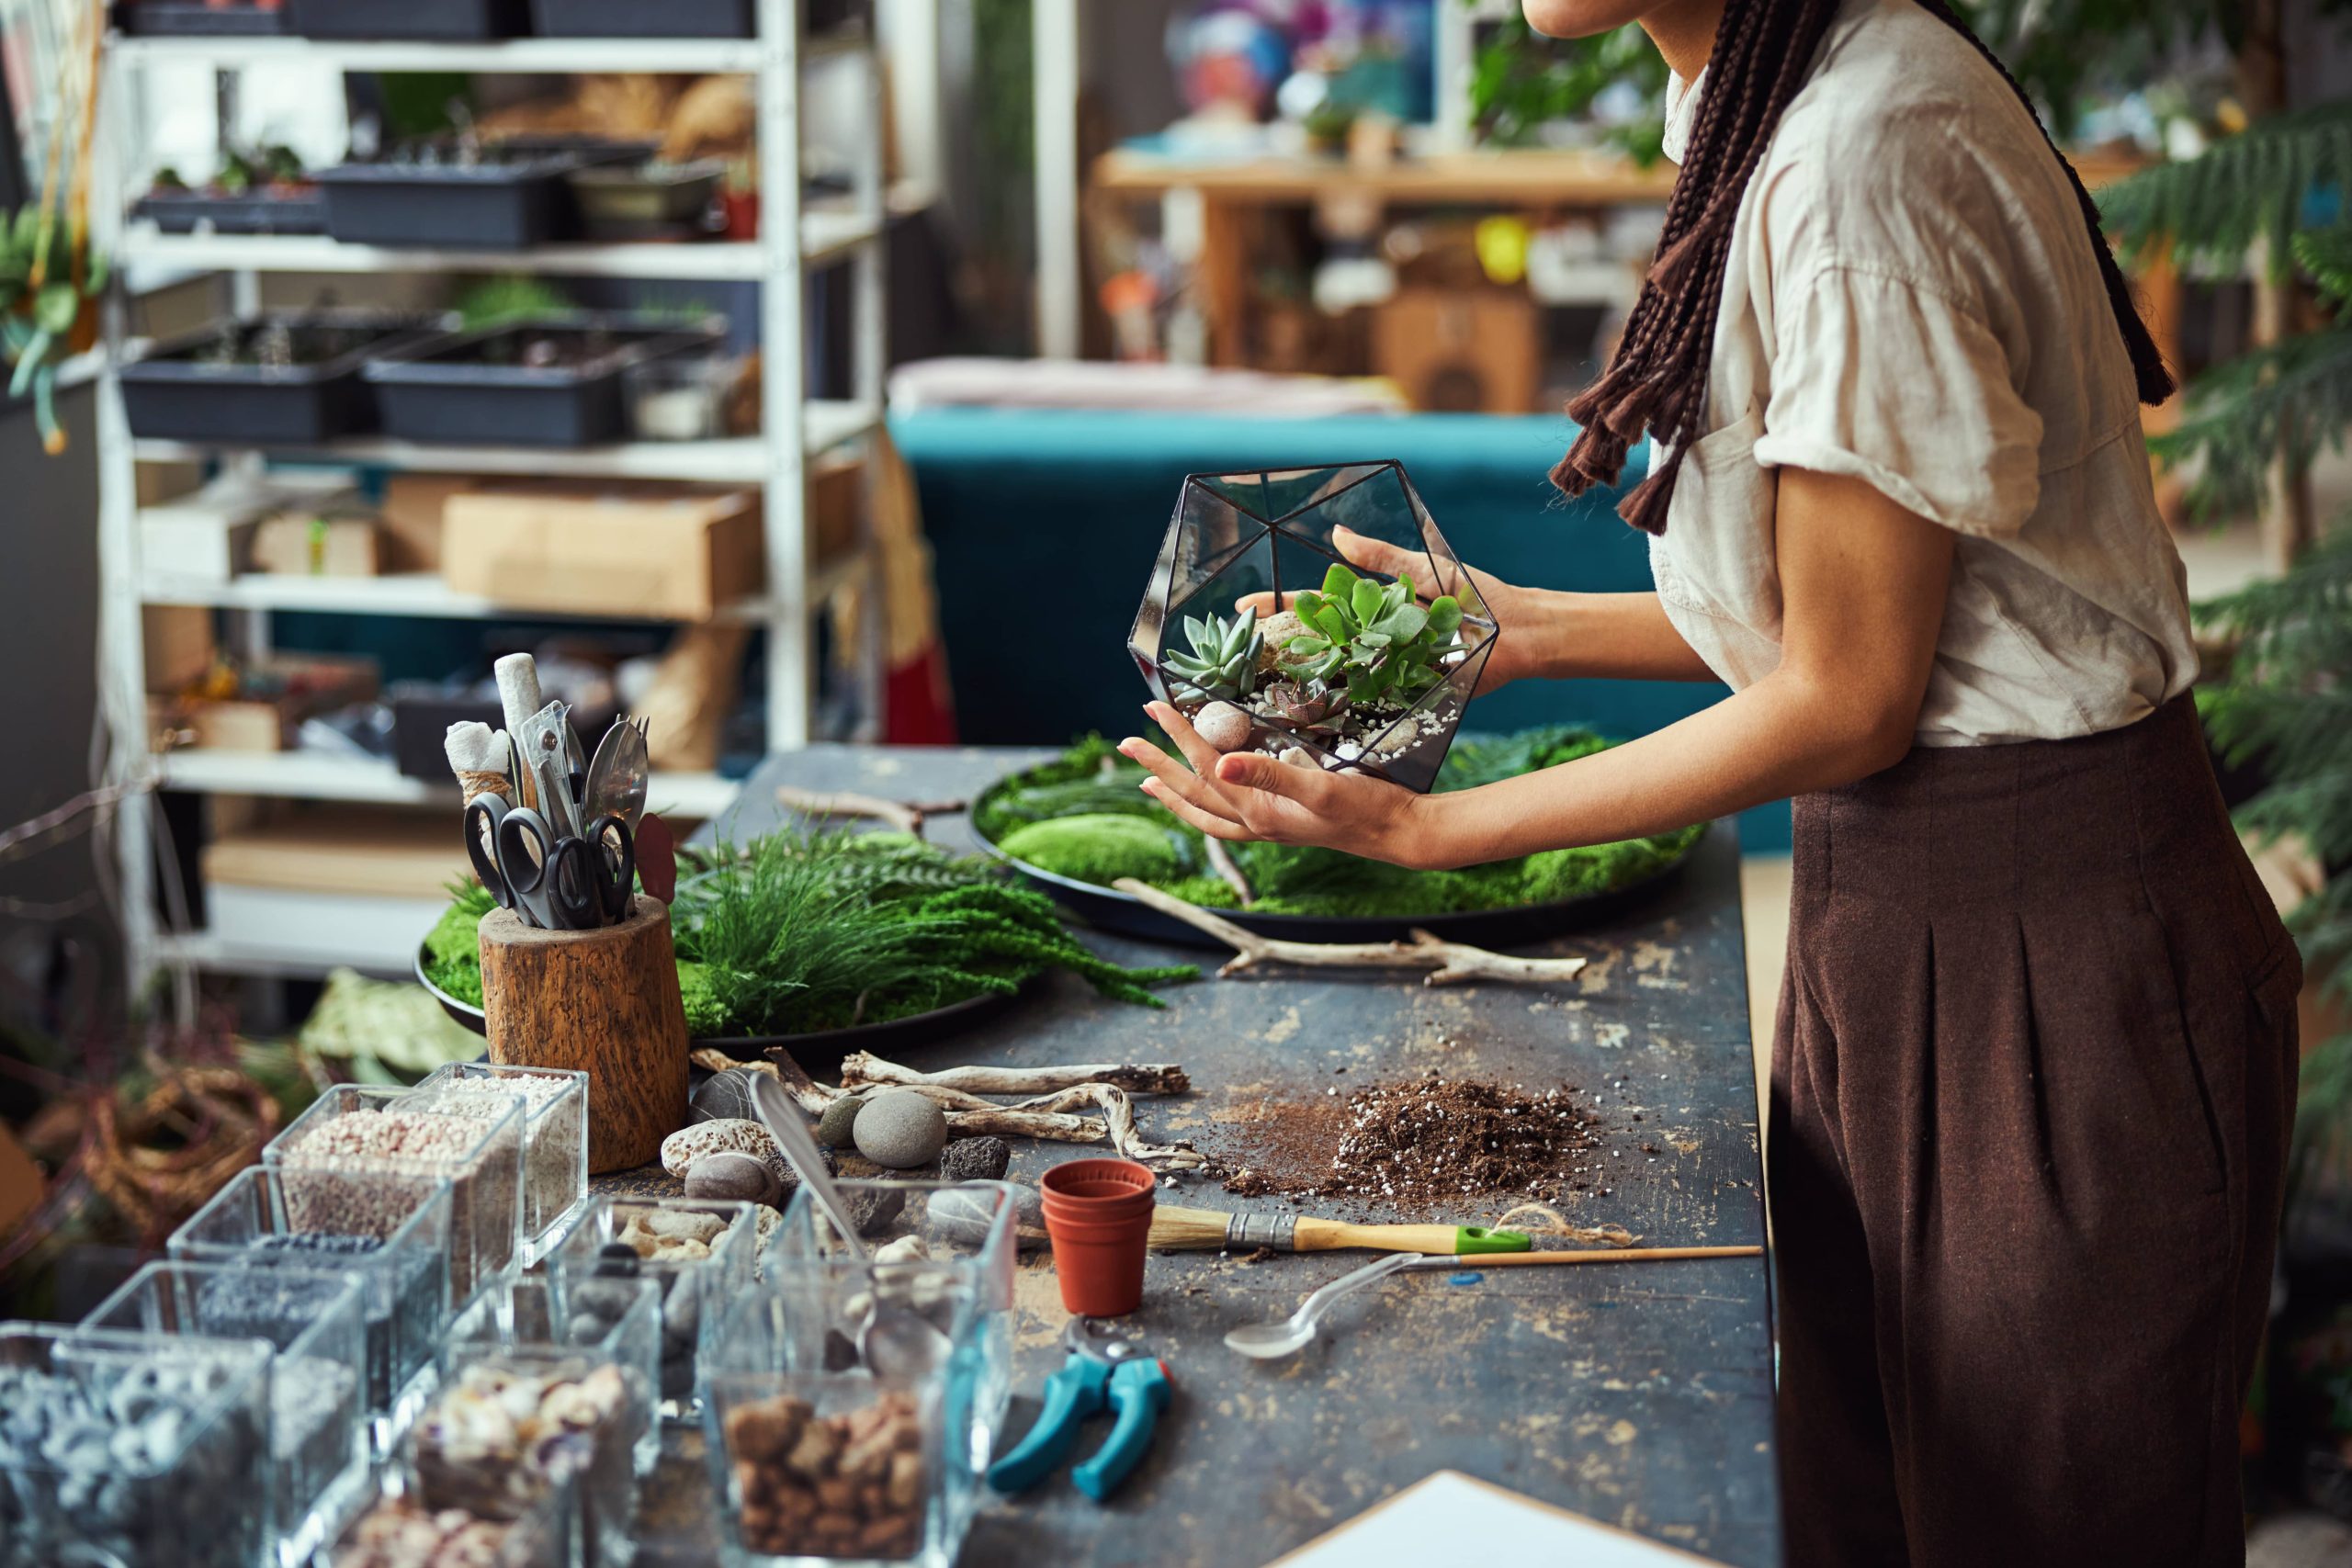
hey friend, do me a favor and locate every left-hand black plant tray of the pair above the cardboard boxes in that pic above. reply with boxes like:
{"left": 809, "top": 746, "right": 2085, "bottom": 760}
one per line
{"left": 122, "top": 310, "right": 460, "bottom": 446}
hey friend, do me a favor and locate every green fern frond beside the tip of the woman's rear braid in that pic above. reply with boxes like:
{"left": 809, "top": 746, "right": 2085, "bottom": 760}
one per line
{"left": 2150, "top": 324, "right": 2352, "bottom": 517}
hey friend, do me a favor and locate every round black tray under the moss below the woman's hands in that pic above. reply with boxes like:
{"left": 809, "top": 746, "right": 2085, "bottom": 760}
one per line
{"left": 974, "top": 802, "right": 1714, "bottom": 950}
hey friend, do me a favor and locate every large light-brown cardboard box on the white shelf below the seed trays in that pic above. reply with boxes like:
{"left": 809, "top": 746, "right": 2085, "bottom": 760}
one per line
{"left": 442, "top": 479, "right": 767, "bottom": 621}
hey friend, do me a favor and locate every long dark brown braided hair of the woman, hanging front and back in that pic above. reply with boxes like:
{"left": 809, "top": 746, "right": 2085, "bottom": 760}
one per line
{"left": 1553, "top": 0, "right": 2173, "bottom": 534}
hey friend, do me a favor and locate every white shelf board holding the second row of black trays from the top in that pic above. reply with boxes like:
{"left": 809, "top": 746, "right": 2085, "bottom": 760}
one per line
{"left": 120, "top": 211, "right": 879, "bottom": 282}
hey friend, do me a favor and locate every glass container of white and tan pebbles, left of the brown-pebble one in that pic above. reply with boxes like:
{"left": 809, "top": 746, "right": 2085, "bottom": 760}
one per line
{"left": 400, "top": 1342, "right": 638, "bottom": 1568}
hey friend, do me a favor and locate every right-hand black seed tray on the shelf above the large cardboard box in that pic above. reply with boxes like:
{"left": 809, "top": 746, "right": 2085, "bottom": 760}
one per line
{"left": 367, "top": 320, "right": 713, "bottom": 446}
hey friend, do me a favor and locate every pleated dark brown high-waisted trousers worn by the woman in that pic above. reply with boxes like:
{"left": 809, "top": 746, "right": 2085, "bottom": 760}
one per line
{"left": 1769, "top": 698, "right": 2302, "bottom": 1568}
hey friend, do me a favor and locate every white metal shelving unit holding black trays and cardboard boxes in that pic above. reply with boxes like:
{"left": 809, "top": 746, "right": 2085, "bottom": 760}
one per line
{"left": 99, "top": 0, "right": 889, "bottom": 985}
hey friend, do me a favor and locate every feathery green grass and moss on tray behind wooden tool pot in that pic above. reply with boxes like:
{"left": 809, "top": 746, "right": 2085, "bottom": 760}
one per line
{"left": 425, "top": 832, "right": 1200, "bottom": 1039}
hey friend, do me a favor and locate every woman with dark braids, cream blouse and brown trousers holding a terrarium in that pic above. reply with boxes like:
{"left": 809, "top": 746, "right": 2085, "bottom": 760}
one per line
{"left": 1122, "top": 0, "right": 2301, "bottom": 1568}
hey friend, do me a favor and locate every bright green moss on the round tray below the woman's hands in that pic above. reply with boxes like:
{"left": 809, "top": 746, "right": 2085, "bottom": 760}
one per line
{"left": 971, "top": 727, "right": 1705, "bottom": 919}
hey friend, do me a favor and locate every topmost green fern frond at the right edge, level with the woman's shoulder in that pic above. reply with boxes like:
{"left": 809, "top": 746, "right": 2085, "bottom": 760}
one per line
{"left": 2098, "top": 101, "right": 2352, "bottom": 270}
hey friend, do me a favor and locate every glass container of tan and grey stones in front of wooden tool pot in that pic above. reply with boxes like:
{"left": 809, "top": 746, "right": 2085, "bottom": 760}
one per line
{"left": 548, "top": 1197, "right": 757, "bottom": 1420}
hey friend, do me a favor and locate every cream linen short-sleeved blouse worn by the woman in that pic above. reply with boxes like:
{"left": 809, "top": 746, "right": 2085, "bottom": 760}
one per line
{"left": 1651, "top": 0, "right": 2197, "bottom": 745}
